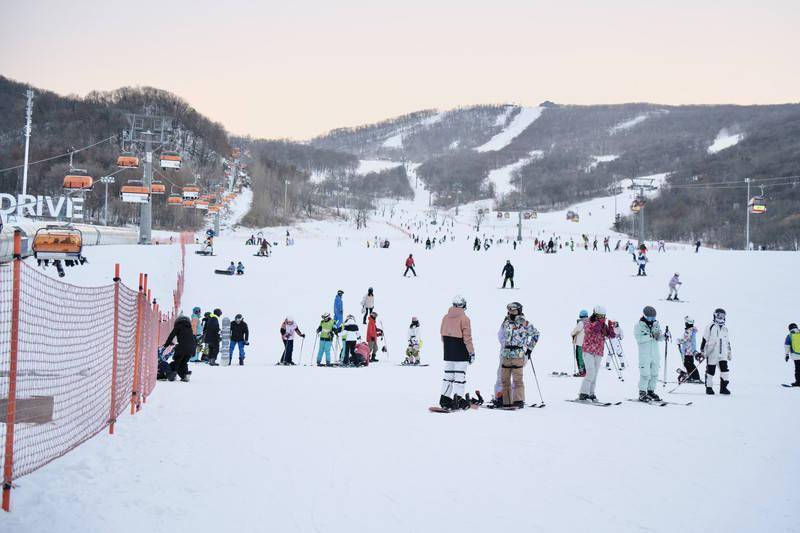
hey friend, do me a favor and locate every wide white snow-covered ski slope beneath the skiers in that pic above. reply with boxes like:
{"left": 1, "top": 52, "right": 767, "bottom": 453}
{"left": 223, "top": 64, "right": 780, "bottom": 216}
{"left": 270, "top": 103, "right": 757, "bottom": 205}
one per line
{"left": 0, "top": 166, "right": 800, "bottom": 533}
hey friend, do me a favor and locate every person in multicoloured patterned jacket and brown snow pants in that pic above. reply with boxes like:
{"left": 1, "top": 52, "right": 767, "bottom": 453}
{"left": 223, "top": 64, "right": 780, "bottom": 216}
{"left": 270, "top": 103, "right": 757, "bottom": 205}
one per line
{"left": 494, "top": 302, "right": 539, "bottom": 408}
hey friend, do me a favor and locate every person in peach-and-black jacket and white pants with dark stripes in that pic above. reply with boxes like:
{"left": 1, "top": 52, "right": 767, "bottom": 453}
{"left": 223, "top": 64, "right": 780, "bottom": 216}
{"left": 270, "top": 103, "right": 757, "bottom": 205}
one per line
{"left": 439, "top": 295, "right": 475, "bottom": 409}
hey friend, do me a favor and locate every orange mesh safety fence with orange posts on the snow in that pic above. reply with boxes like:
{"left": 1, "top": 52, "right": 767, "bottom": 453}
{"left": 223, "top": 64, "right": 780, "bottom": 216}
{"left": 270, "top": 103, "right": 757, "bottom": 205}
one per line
{"left": 0, "top": 232, "right": 192, "bottom": 511}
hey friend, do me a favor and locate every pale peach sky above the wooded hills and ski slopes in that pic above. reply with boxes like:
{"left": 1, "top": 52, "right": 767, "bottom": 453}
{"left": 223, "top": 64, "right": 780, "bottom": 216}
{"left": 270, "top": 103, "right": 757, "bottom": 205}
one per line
{"left": 0, "top": 0, "right": 800, "bottom": 139}
